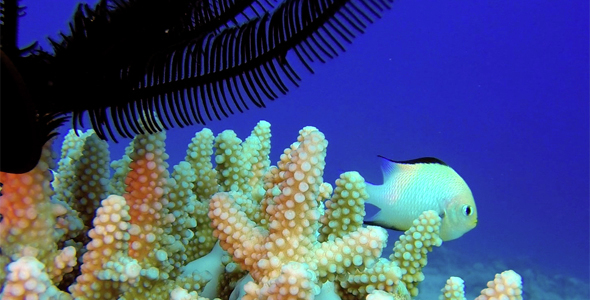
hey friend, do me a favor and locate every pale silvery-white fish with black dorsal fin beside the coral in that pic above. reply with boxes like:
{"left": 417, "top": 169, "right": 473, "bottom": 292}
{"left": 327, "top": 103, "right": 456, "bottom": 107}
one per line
{"left": 364, "top": 155, "right": 478, "bottom": 241}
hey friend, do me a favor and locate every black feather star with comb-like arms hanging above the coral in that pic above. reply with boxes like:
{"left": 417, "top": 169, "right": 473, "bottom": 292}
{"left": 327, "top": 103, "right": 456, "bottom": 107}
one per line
{"left": 0, "top": 0, "right": 393, "bottom": 173}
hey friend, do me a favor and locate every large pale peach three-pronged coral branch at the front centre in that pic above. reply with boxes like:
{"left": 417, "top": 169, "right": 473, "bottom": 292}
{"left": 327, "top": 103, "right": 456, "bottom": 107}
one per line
{"left": 209, "top": 127, "right": 394, "bottom": 299}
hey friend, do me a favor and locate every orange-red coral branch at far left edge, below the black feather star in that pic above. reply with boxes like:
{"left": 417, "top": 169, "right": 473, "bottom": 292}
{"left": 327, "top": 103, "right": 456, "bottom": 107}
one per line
{"left": 0, "top": 146, "right": 76, "bottom": 282}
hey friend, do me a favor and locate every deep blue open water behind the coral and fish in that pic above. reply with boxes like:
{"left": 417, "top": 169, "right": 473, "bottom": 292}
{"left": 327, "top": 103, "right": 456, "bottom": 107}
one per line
{"left": 19, "top": 0, "right": 590, "bottom": 299}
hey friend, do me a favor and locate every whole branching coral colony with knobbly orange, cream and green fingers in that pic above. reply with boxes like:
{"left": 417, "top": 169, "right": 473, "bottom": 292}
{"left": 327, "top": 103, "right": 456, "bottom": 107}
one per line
{"left": 0, "top": 121, "right": 522, "bottom": 300}
